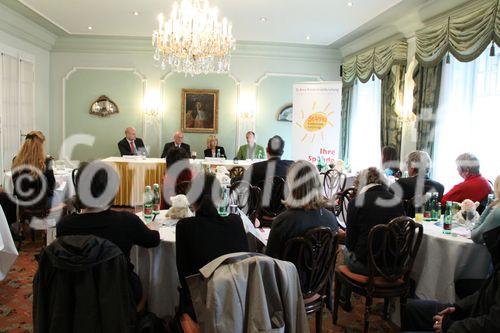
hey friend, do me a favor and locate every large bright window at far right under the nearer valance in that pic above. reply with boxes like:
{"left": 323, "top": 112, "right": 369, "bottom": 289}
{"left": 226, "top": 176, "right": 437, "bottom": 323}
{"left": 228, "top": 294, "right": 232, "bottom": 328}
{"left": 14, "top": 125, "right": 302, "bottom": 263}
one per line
{"left": 434, "top": 48, "right": 500, "bottom": 189}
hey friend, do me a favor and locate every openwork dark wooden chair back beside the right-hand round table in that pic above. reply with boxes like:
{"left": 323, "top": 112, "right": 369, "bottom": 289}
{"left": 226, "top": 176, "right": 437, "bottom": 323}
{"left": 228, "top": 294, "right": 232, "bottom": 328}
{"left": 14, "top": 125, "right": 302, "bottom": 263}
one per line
{"left": 368, "top": 216, "right": 424, "bottom": 287}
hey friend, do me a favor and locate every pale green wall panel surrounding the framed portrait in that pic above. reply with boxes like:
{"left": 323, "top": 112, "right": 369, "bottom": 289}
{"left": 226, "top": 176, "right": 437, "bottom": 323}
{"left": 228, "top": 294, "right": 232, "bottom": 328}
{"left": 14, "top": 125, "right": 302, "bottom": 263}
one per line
{"left": 162, "top": 74, "right": 238, "bottom": 158}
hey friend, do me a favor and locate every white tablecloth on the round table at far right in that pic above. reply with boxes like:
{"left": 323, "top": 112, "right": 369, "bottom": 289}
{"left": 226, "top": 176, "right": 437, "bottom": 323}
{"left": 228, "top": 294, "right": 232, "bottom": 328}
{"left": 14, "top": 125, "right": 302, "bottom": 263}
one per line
{"left": 411, "top": 222, "right": 491, "bottom": 303}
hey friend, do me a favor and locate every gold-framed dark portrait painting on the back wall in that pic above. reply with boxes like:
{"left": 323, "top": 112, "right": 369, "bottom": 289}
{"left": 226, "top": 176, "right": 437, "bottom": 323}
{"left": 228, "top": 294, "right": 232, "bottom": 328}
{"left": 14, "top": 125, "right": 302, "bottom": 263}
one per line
{"left": 181, "top": 89, "right": 219, "bottom": 133}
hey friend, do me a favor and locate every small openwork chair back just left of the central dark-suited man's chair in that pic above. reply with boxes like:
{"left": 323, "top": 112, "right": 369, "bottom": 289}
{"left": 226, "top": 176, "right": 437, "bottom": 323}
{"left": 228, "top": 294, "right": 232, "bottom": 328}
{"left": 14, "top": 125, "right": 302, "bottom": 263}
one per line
{"left": 229, "top": 180, "right": 261, "bottom": 217}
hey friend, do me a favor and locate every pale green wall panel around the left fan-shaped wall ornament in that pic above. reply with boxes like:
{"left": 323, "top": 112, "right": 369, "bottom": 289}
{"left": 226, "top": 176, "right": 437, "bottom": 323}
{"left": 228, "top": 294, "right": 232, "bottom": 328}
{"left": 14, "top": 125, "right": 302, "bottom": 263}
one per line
{"left": 65, "top": 69, "right": 142, "bottom": 161}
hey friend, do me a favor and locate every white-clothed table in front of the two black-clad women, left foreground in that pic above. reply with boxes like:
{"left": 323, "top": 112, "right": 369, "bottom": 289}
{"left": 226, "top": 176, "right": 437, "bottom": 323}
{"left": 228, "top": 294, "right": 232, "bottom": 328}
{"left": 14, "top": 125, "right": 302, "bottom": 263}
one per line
{"left": 130, "top": 210, "right": 269, "bottom": 318}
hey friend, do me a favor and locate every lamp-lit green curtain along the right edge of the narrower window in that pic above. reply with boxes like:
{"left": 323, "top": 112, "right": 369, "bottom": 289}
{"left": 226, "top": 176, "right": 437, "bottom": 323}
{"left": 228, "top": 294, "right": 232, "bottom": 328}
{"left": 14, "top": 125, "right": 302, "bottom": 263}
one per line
{"left": 380, "top": 65, "right": 406, "bottom": 155}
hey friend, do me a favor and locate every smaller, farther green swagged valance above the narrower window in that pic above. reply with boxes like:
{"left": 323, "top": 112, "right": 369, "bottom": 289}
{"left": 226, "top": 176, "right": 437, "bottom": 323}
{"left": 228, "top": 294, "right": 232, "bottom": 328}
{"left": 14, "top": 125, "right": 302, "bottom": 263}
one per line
{"left": 342, "top": 41, "right": 408, "bottom": 85}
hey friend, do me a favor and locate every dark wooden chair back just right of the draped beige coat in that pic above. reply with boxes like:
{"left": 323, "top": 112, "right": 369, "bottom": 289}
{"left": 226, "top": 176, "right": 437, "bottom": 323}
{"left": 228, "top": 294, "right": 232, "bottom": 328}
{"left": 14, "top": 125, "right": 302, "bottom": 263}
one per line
{"left": 283, "top": 227, "right": 338, "bottom": 298}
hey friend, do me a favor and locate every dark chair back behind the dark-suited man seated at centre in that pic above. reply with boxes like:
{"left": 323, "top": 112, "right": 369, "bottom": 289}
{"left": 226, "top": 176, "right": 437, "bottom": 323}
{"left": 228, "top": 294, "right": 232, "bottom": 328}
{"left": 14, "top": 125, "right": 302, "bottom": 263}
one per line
{"left": 258, "top": 176, "right": 286, "bottom": 217}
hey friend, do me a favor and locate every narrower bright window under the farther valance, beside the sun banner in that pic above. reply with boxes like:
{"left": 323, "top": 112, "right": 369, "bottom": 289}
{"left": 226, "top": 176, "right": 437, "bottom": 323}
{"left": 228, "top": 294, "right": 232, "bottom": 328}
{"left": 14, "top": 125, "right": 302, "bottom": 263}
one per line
{"left": 349, "top": 78, "right": 382, "bottom": 171}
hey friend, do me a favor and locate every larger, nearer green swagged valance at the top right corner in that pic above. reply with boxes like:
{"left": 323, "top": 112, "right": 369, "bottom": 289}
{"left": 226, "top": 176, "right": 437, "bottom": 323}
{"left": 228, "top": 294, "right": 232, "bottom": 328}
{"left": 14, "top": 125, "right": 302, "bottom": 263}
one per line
{"left": 416, "top": 0, "right": 500, "bottom": 67}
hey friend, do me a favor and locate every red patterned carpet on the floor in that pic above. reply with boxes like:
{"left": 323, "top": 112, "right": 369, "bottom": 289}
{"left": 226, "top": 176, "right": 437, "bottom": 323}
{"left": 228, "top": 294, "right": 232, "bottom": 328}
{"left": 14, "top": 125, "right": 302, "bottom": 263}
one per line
{"left": 0, "top": 237, "right": 398, "bottom": 333}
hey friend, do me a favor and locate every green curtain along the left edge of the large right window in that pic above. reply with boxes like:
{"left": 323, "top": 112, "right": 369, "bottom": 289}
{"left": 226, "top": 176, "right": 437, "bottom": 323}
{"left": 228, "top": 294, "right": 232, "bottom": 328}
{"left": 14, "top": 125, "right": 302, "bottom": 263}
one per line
{"left": 413, "top": 62, "right": 442, "bottom": 157}
